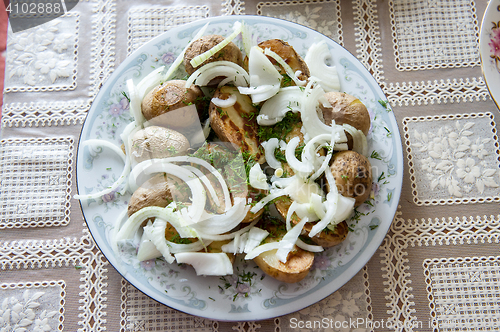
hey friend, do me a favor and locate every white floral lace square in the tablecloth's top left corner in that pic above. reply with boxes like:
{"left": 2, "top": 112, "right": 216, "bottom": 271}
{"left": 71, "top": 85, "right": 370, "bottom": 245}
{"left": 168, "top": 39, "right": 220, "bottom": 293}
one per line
{"left": 5, "top": 13, "right": 79, "bottom": 92}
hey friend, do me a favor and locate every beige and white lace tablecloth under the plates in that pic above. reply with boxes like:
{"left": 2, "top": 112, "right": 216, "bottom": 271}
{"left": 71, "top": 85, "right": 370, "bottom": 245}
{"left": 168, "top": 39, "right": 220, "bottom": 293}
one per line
{"left": 0, "top": 0, "right": 500, "bottom": 332}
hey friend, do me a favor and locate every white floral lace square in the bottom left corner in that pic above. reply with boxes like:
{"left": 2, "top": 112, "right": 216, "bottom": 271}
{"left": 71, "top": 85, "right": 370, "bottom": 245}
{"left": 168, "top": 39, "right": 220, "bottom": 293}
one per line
{"left": 0, "top": 281, "right": 65, "bottom": 332}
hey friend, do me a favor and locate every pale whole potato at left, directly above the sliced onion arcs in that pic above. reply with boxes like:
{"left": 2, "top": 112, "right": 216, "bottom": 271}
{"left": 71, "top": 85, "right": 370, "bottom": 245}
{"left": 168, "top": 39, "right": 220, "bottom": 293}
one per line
{"left": 130, "top": 126, "right": 190, "bottom": 162}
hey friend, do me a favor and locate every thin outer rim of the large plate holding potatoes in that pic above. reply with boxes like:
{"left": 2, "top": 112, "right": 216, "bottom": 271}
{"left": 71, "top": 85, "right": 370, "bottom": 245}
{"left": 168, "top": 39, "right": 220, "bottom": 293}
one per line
{"left": 75, "top": 15, "right": 405, "bottom": 322}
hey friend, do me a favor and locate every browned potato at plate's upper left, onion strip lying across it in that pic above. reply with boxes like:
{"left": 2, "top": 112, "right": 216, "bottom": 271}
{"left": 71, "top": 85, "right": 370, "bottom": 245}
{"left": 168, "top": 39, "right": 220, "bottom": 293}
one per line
{"left": 184, "top": 35, "right": 243, "bottom": 75}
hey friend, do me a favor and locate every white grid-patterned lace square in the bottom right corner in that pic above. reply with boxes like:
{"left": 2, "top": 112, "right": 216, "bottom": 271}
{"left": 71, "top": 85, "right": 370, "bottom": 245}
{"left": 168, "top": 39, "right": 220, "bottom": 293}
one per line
{"left": 423, "top": 256, "right": 500, "bottom": 332}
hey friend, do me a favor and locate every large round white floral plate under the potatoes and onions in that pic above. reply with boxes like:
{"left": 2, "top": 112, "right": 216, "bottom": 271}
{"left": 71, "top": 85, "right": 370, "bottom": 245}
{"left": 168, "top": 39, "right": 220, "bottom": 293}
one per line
{"left": 77, "top": 16, "right": 403, "bottom": 321}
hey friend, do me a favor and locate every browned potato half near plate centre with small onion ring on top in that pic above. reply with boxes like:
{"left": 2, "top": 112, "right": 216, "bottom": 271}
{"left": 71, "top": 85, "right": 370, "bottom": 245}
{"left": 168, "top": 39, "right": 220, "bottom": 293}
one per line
{"left": 208, "top": 86, "right": 265, "bottom": 164}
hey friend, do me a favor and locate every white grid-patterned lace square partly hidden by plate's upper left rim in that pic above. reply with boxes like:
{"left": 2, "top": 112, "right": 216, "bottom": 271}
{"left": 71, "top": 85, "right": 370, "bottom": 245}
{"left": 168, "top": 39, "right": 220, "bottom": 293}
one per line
{"left": 128, "top": 6, "right": 210, "bottom": 54}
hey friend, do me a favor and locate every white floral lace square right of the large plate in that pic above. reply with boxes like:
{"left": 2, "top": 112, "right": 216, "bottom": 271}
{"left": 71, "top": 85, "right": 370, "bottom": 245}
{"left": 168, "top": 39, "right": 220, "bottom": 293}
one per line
{"left": 404, "top": 113, "right": 500, "bottom": 205}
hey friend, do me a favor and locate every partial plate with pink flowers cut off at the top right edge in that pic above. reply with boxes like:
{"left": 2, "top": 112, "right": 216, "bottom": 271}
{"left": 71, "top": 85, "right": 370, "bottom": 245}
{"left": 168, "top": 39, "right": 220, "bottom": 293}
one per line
{"left": 479, "top": 0, "right": 500, "bottom": 107}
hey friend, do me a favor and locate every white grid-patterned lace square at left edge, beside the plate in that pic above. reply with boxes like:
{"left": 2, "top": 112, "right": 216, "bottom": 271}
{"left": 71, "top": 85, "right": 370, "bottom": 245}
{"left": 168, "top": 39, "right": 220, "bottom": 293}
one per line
{"left": 0, "top": 137, "right": 73, "bottom": 229}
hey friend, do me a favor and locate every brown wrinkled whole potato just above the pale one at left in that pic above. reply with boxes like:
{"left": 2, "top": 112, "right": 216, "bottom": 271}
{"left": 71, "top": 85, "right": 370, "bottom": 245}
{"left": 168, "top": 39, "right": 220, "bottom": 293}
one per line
{"left": 141, "top": 80, "right": 206, "bottom": 129}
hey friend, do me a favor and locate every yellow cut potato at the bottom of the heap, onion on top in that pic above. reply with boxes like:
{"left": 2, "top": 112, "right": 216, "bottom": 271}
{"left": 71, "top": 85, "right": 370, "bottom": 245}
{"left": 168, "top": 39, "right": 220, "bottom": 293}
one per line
{"left": 253, "top": 219, "right": 314, "bottom": 283}
